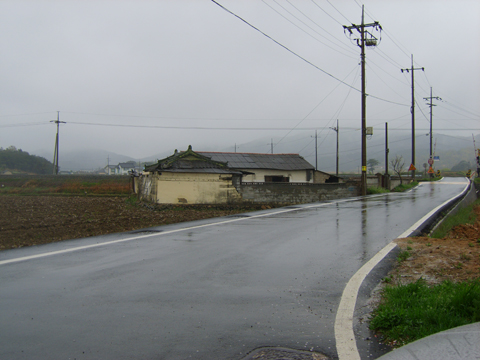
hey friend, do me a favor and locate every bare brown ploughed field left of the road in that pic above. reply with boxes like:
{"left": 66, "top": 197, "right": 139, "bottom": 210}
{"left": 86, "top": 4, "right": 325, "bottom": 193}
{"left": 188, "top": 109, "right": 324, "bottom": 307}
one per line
{"left": 0, "top": 196, "right": 266, "bottom": 250}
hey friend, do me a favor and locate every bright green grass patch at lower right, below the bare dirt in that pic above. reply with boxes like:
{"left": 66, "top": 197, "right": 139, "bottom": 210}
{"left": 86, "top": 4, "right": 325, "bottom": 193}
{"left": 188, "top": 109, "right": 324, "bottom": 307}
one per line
{"left": 370, "top": 279, "right": 480, "bottom": 345}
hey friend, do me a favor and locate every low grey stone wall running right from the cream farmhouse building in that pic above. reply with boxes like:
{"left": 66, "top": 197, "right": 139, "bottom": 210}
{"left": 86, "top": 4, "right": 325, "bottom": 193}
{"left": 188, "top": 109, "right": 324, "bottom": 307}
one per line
{"left": 235, "top": 182, "right": 359, "bottom": 204}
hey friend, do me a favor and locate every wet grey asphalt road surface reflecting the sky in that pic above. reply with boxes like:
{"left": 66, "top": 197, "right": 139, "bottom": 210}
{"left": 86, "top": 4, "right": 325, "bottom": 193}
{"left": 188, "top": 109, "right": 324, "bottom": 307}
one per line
{"left": 0, "top": 178, "right": 467, "bottom": 360}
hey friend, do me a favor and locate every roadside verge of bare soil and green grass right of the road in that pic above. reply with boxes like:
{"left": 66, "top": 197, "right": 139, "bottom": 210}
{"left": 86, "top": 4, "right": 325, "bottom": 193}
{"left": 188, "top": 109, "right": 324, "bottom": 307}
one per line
{"left": 370, "top": 200, "right": 480, "bottom": 347}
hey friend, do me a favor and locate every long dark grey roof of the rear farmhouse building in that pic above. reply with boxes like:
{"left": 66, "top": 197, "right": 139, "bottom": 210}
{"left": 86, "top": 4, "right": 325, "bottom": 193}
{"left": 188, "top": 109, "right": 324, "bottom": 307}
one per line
{"left": 197, "top": 151, "right": 315, "bottom": 170}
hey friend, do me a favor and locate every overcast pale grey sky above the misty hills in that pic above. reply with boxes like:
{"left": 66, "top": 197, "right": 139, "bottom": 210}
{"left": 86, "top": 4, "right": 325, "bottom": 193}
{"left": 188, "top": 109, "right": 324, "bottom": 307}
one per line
{"left": 0, "top": 0, "right": 480, "bottom": 158}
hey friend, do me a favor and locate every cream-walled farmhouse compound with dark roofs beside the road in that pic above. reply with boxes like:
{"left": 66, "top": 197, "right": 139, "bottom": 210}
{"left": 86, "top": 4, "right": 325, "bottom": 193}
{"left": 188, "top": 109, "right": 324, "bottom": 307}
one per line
{"left": 134, "top": 146, "right": 350, "bottom": 204}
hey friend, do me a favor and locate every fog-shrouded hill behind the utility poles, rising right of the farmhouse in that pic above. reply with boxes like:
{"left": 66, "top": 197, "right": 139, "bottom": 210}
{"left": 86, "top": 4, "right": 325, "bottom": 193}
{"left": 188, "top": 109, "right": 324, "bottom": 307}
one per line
{"left": 218, "top": 128, "right": 480, "bottom": 172}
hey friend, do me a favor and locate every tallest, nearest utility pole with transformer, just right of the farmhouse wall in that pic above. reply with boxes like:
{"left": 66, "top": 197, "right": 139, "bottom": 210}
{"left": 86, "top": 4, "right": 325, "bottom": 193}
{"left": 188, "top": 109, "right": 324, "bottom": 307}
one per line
{"left": 343, "top": 5, "right": 382, "bottom": 195}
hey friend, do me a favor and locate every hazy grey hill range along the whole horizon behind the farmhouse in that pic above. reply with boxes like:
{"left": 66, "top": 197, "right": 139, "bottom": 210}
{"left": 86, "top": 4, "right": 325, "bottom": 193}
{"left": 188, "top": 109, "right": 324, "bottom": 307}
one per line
{"left": 33, "top": 128, "right": 480, "bottom": 172}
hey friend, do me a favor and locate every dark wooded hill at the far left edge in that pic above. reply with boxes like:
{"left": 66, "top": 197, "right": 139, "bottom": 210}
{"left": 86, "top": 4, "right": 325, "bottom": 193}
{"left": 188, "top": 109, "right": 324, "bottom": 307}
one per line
{"left": 0, "top": 146, "right": 53, "bottom": 175}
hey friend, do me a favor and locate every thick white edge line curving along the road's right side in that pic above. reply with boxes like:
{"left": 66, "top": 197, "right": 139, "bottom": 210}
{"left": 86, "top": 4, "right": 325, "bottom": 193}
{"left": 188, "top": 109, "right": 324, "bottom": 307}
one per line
{"left": 334, "top": 183, "right": 469, "bottom": 360}
